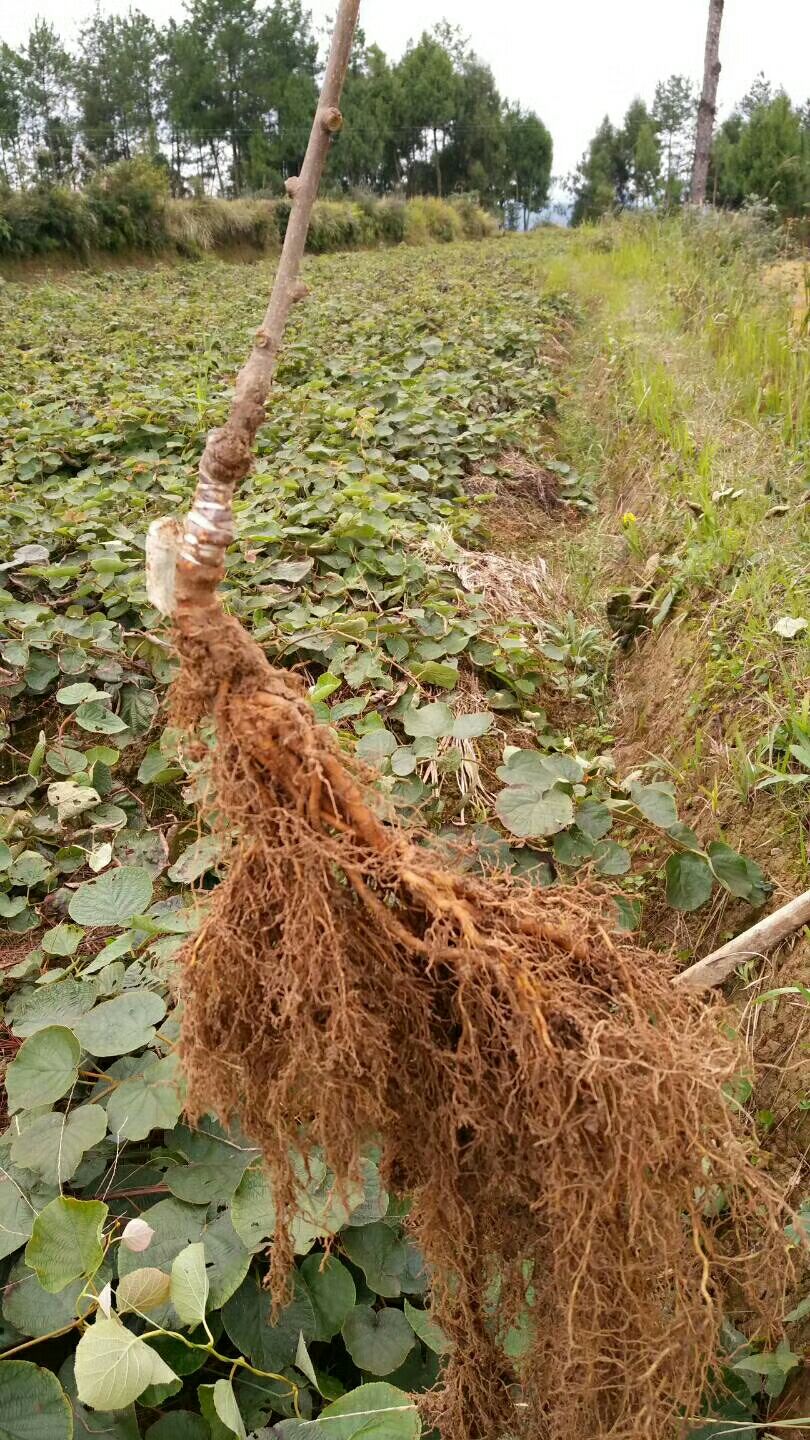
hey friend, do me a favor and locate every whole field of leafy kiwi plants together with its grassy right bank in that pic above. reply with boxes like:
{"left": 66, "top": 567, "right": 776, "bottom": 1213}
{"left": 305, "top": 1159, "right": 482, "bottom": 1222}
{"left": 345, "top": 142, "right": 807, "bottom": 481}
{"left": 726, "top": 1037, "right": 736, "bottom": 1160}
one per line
{"left": 0, "top": 222, "right": 810, "bottom": 1440}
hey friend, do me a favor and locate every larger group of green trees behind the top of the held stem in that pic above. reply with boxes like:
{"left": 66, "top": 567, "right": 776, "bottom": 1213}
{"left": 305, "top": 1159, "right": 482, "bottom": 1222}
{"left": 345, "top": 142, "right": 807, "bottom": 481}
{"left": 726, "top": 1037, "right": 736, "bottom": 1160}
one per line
{"left": 0, "top": 0, "right": 552, "bottom": 215}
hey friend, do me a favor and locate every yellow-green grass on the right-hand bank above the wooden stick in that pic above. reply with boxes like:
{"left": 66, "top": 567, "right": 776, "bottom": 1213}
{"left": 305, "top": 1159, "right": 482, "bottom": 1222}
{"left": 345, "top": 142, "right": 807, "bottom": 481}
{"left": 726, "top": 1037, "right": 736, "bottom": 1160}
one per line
{"left": 549, "top": 213, "right": 810, "bottom": 904}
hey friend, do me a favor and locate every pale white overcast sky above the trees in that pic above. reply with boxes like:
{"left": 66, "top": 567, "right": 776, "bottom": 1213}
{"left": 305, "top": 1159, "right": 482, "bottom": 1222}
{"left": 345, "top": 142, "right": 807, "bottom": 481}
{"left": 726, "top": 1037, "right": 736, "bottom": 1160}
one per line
{"left": 0, "top": 0, "right": 810, "bottom": 174}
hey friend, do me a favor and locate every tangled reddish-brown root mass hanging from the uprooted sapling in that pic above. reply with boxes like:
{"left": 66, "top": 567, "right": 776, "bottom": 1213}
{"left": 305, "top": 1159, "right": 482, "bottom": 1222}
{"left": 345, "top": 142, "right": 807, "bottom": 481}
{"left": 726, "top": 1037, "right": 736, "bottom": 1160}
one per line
{"left": 174, "top": 612, "right": 781, "bottom": 1440}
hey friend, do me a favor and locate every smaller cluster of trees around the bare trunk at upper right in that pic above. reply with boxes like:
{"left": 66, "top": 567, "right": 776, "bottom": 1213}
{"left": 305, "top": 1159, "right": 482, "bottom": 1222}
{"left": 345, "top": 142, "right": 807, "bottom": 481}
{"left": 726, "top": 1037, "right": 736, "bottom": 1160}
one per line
{"left": 569, "top": 75, "right": 810, "bottom": 225}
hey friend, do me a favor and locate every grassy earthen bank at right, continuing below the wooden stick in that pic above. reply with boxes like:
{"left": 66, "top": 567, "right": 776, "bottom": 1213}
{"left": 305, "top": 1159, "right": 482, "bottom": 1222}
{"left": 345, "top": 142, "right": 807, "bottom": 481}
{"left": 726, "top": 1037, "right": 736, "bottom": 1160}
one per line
{"left": 536, "top": 220, "right": 810, "bottom": 1313}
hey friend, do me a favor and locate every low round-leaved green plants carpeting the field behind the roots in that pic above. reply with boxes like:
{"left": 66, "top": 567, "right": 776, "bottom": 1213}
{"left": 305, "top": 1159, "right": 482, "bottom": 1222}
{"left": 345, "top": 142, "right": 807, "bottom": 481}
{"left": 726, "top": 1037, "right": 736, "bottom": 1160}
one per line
{"left": 0, "top": 221, "right": 807, "bottom": 1440}
